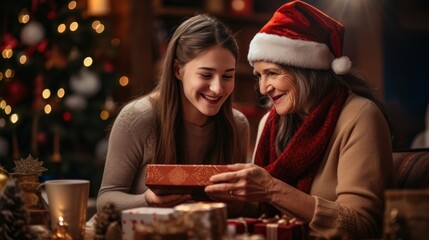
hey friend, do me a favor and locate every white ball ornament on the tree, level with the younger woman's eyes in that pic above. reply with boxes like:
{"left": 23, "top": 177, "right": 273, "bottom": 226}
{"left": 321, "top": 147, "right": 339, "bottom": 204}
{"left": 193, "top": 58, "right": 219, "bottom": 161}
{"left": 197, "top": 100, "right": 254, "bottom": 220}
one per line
{"left": 70, "top": 68, "right": 101, "bottom": 97}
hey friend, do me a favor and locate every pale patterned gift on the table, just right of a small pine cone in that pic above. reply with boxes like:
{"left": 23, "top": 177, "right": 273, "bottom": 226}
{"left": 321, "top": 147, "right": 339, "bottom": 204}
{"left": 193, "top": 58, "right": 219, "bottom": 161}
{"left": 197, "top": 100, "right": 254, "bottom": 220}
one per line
{"left": 121, "top": 207, "right": 177, "bottom": 240}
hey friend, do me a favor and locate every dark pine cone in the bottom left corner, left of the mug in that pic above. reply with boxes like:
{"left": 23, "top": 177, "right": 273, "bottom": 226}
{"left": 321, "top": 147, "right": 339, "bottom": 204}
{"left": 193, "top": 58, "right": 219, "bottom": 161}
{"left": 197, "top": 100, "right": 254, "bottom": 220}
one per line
{"left": 0, "top": 179, "right": 37, "bottom": 240}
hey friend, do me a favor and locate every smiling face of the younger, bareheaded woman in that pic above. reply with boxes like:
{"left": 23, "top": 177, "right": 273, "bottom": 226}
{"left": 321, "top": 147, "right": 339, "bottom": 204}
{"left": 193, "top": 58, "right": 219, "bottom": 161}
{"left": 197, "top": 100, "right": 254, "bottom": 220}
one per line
{"left": 175, "top": 45, "right": 236, "bottom": 126}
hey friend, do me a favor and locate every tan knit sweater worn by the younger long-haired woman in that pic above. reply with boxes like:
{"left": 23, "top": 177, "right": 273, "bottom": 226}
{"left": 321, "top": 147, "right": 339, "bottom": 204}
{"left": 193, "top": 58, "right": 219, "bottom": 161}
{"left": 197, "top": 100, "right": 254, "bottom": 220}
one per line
{"left": 97, "top": 97, "right": 249, "bottom": 210}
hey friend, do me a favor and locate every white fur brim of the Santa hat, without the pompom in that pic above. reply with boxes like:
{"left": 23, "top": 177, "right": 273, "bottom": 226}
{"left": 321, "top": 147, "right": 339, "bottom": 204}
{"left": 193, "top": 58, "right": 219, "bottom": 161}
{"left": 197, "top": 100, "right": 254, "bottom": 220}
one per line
{"left": 247, "top": 33, "right": 334, "bottom": 69}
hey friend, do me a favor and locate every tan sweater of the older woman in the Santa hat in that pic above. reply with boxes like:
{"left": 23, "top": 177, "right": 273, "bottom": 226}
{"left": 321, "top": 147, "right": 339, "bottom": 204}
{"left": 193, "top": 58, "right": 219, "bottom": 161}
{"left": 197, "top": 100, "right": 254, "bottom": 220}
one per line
{"left": 252, "top": 94, "right": 393, "bottom": 239}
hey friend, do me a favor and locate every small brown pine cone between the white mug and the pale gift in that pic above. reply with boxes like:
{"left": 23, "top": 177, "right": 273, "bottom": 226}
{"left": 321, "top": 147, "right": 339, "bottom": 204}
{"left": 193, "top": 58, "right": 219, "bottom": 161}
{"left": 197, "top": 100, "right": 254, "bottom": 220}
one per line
{"left": 95, "top": 202, "right": 121, "bottom": 236}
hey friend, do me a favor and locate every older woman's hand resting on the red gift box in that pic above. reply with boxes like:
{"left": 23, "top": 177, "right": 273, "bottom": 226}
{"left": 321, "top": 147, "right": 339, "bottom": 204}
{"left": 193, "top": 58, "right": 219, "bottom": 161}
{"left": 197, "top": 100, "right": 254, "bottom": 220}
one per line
{"left": 205, "top": 163, "right": 274, "bottom": 202}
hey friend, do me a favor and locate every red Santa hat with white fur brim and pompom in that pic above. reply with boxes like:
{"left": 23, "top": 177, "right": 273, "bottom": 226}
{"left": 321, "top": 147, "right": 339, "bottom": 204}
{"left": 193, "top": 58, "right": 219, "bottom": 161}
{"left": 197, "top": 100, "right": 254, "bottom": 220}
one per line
{"left": 247, "top": 1, "right": 351, "bottom": 74}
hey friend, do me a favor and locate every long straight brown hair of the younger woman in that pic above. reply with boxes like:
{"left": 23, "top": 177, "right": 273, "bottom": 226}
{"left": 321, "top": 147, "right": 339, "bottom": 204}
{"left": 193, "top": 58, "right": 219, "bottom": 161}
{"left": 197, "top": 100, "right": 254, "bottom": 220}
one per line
{"left": 152, "top": 14, "right": 239, "bottom": 164}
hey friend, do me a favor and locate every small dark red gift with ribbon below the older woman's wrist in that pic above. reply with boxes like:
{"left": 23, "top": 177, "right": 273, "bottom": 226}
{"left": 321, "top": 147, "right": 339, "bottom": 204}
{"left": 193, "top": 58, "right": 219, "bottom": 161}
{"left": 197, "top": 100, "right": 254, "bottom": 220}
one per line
{"left": 254, "top": 217, "right": 308, "bottom": 240}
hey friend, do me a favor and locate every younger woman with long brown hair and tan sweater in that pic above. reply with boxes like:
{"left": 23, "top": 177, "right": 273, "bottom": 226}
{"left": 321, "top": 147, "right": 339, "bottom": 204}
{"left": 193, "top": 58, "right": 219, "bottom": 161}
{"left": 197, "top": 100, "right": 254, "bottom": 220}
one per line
{"left": 97, "top": 14, "right": 249, "bottom": 210}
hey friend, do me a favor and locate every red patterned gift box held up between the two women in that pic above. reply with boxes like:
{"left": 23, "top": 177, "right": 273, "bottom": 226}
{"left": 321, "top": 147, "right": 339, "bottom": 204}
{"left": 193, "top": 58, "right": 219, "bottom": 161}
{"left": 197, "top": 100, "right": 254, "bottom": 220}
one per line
{"left": 146, "top": 164, "right": 228, "bottom": 200}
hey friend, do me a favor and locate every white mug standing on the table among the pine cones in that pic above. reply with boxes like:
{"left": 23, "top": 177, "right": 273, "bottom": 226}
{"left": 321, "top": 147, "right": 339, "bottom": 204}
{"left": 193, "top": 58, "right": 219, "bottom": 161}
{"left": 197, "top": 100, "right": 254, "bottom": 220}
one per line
{"left": 39, "top": 179, "right": 89, "bottom": 240}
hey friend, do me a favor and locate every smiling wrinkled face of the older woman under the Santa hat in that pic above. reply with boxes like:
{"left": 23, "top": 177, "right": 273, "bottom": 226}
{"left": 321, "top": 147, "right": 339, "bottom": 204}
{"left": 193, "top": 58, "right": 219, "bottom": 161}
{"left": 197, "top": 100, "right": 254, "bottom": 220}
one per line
{"left": 253, "top": 61, "right": 297, "bottom": 116}
